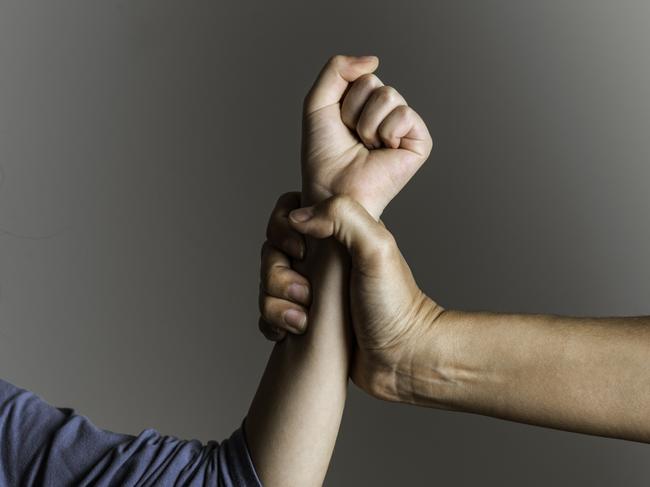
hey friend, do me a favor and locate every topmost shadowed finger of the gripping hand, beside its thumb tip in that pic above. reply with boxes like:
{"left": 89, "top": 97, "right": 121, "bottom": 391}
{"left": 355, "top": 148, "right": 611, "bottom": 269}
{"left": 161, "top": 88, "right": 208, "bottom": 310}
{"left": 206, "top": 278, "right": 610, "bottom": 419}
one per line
{"left": 266, "top": 191, "right": 305, "bottom": 259}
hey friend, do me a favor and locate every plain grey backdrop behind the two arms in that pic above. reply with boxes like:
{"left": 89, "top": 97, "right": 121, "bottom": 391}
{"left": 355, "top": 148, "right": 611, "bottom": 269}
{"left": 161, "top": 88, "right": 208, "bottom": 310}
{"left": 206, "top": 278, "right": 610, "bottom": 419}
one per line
{"left": 0, "top": 0, "right": 650, "bottom": 486}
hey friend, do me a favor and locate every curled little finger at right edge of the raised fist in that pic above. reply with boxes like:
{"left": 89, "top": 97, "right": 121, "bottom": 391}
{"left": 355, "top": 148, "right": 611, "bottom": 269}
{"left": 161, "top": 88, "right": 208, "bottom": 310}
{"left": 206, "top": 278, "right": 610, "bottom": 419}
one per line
{"left": 377, "top": 105, "right": 433, "bottom": 158}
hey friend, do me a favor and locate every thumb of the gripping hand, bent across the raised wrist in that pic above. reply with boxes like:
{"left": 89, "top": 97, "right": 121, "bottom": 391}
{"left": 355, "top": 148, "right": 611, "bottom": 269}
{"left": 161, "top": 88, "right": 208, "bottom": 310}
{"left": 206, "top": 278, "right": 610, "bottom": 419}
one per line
{"left": 289, "top": 195, "right": 397, "bottom": 266}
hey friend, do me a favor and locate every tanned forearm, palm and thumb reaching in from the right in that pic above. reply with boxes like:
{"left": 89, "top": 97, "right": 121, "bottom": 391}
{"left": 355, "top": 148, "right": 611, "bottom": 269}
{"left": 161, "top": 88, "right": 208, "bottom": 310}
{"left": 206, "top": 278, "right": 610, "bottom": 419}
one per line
{"left": 261, "top": 197, "right": 650, "bottom": 442}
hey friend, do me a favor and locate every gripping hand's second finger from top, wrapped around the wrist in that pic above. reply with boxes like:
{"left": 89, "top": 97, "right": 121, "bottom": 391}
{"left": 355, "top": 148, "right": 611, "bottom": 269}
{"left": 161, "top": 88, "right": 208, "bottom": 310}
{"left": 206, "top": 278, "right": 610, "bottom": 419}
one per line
{"left": 260, "top": 243, "right": 310, "bottom": 306}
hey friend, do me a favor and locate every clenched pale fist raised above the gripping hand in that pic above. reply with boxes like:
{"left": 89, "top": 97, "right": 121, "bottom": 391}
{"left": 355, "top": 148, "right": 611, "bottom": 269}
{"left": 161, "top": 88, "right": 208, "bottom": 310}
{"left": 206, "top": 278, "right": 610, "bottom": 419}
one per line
{"left": 302, "top": 56, "right": 432, "bottom": 219}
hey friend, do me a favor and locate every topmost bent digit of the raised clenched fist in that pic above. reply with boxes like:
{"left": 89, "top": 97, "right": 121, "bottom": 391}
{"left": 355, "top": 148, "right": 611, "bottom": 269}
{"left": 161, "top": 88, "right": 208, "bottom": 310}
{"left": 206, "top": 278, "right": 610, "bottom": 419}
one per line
{"left": 304, "top": 55, "right": 379, "bottom": 114}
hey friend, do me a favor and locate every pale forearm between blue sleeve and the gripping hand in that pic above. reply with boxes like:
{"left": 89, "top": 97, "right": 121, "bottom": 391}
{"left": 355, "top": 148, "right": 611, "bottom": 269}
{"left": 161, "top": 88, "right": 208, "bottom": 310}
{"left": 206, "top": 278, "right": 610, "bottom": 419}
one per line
{"left": 246, "top": 241, "right": 350, "bottom": 487}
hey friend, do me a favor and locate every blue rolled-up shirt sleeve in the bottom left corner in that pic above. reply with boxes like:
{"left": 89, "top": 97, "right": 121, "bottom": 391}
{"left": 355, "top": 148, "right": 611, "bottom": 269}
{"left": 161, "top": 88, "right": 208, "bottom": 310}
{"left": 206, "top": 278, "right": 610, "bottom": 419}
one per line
{"left": 0, "top": 380, "right": 262, "bottom": 487}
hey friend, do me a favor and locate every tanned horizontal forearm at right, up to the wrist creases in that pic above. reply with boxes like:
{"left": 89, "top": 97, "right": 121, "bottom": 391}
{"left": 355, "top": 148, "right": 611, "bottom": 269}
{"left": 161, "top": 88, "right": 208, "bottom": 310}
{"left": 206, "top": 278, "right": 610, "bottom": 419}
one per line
{"left": 396, "top": 310, "right": 650, "bottom": 442}
